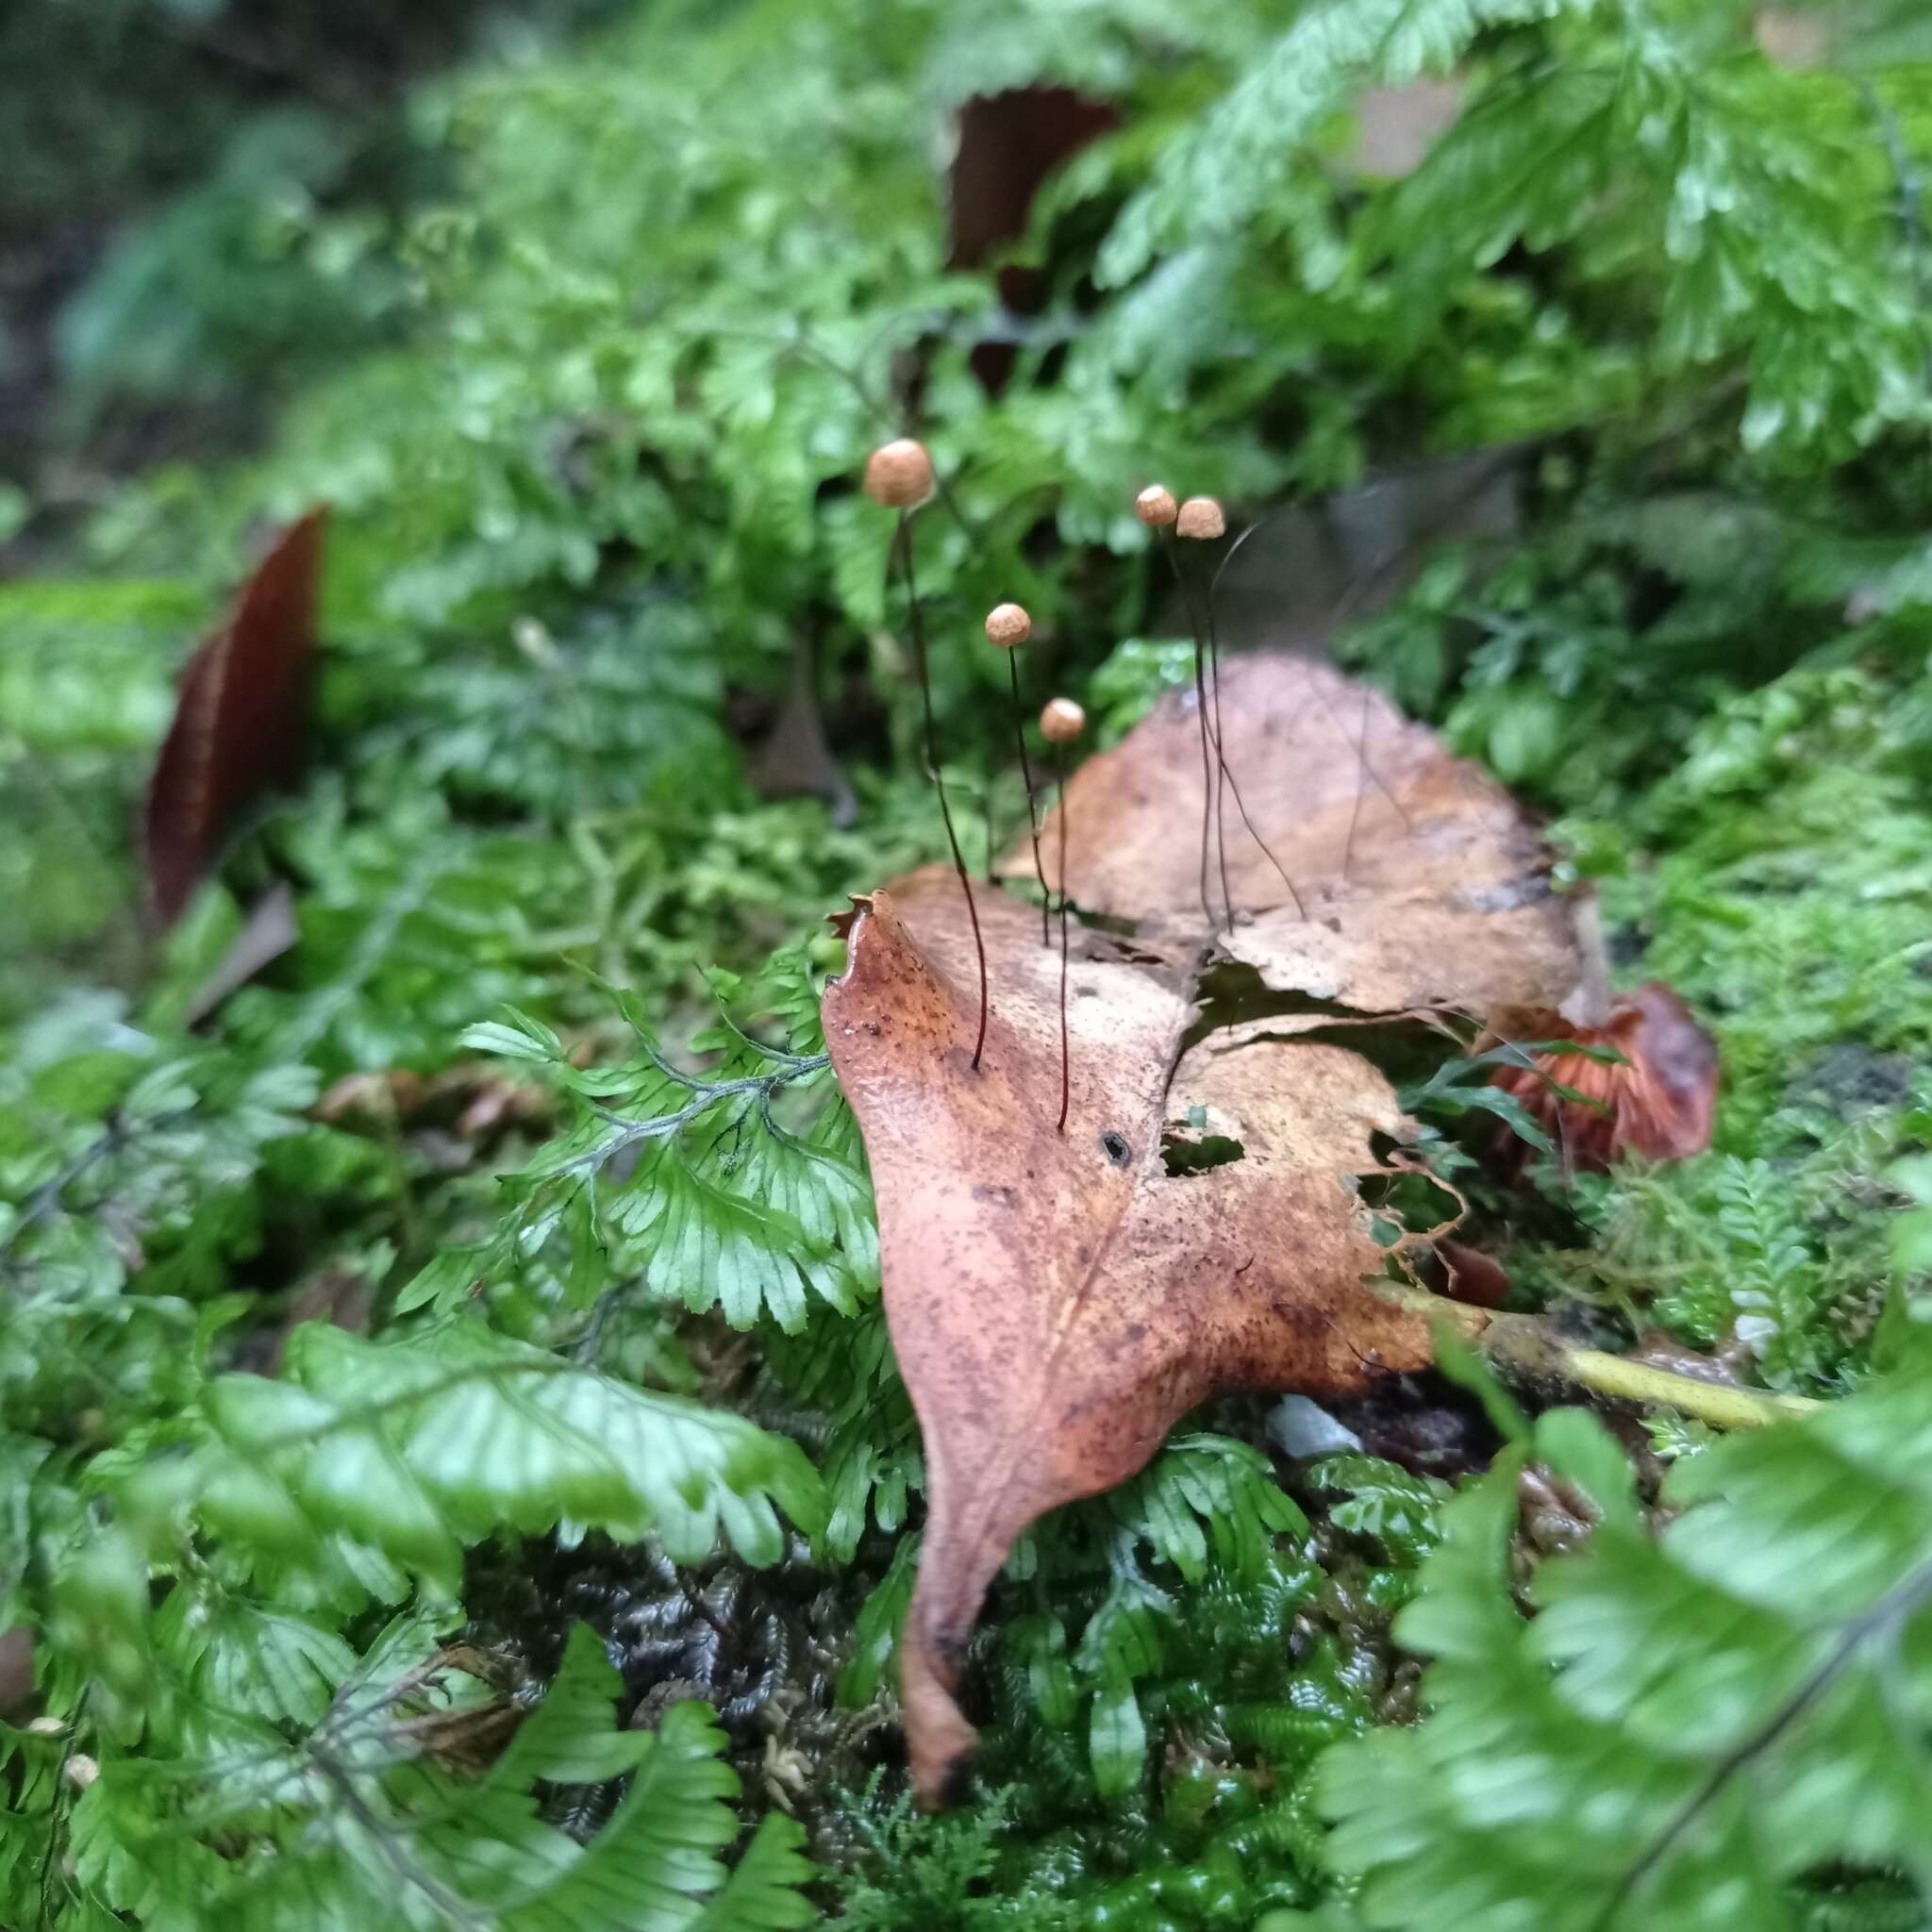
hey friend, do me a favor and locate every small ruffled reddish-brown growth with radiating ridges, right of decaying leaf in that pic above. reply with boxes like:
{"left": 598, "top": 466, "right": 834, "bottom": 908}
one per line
{"left": 1495, "top": 979, "right": 1718, "bottom": 1171}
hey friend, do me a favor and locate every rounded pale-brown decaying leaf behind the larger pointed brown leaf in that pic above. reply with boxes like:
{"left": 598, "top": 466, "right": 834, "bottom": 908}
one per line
{"left": 1001, "top": 653, "right": 1607, "bottom": 1024}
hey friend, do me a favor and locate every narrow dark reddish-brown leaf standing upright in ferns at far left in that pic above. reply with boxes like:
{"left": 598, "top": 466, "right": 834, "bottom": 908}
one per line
{"left": 142, "top": 510, "right": 326, "bottom": 927}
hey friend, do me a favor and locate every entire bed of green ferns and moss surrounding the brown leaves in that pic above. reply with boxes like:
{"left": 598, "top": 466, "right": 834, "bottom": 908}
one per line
{"left": 11, "top": 0, "right": 1932, "bottom": 1932}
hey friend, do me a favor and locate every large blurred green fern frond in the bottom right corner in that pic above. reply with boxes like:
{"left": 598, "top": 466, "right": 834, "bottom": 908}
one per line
{"left": 1324, "top": 1368, "right": 1932, "bottom": 1928}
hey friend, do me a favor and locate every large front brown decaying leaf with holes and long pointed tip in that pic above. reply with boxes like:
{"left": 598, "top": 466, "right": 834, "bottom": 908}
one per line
{"left": 824, "top": 868, "right": 1430, "bottom": 1803}
